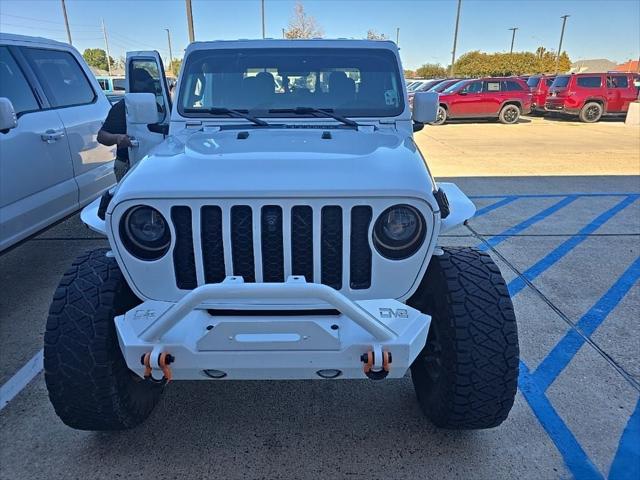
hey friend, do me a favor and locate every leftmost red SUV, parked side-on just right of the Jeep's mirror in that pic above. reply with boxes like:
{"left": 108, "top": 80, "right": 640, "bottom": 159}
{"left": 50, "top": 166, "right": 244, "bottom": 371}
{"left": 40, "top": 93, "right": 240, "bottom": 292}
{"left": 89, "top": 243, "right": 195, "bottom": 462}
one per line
{"left": 433, "top": 77, "right": 531, "bottom": 125}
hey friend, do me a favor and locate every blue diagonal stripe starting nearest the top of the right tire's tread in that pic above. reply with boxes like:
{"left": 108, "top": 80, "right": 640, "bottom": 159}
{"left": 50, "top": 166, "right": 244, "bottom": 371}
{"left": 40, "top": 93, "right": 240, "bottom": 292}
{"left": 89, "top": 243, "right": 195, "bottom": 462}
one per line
{"left": 508, "top": 195, "right": 639, "bottom": 297}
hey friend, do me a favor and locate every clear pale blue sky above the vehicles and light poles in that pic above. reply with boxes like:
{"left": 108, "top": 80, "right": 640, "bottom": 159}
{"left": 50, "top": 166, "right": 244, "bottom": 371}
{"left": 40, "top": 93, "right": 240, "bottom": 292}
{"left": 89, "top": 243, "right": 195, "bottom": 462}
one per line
{"left": 0, "top": 0, "right": 640, "bottom": 69}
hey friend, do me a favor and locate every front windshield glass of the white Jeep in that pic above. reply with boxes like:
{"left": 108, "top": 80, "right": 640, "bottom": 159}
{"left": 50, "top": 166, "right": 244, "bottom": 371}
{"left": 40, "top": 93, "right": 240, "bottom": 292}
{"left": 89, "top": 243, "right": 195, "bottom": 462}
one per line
{"left": 178, "top": 48, "right": 404, "bottom": 117}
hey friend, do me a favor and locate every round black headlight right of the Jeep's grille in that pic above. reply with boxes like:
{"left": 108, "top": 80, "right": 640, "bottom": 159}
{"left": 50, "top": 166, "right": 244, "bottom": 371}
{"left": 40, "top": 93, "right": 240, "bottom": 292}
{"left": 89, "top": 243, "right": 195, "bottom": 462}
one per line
{"left": 373, "top": 205, "right": 426, "bottom": 260}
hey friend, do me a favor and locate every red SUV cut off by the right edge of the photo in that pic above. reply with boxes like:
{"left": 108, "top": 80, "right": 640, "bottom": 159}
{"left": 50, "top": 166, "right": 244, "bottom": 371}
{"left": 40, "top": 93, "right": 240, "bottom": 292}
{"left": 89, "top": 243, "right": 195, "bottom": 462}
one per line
{"left": 544, "top": 72, "right": 638, "bottom": 123}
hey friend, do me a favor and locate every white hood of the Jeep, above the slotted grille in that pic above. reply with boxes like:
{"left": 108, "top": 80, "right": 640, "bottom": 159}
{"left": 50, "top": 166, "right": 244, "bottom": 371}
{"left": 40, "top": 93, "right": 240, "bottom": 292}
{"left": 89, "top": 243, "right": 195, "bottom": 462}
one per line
{"left": 113, "top": 128, "right": 434, "bottom": 203}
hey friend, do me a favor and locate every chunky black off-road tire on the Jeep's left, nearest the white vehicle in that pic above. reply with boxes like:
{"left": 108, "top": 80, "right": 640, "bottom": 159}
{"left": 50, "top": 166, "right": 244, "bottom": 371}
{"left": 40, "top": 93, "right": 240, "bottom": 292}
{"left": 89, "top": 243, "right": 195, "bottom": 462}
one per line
{"left": 44, "top": 249, "right": 163, "bottom": 430}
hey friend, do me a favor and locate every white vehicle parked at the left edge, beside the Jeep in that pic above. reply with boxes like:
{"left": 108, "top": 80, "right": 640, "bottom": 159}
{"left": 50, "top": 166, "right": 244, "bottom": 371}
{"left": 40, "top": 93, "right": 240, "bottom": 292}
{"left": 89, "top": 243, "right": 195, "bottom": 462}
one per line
{"left": 0, "top": 33, "right": 115, "bottom": 251}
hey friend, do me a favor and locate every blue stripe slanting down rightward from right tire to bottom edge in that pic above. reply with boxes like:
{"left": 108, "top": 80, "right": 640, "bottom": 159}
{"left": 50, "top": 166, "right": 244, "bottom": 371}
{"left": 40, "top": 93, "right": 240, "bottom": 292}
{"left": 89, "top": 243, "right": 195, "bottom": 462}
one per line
{"left": 518, "top": 361, "right": 603, "bottom": 480}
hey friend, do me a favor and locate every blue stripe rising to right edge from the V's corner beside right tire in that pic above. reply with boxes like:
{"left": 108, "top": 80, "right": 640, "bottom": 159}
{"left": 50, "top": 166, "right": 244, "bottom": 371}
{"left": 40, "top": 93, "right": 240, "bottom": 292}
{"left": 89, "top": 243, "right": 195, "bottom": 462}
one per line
{"left": 532, "top": 257, "right": 640, "bottom": 390}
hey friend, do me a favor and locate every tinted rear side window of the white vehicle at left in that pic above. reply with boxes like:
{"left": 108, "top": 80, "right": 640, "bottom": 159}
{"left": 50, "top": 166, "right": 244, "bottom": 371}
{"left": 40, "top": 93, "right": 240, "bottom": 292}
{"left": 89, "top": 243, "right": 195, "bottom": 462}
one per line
{"left": 23, "top": 48, "right": 96, "bottom": 107}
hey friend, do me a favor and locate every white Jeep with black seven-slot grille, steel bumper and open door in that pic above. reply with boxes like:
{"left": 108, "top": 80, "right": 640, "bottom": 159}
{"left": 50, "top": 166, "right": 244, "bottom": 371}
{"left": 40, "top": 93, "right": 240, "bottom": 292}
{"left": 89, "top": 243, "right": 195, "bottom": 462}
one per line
{"left": 44, "top": 40, "right": 518, "bottom": 430}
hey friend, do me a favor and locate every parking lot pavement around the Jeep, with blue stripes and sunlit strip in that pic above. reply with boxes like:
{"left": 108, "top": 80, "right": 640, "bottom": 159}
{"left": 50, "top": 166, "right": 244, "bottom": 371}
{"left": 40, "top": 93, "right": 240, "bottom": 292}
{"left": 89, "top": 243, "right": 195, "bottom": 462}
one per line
{"left": 0, "top": 118, "right": 640, "bottom": 479}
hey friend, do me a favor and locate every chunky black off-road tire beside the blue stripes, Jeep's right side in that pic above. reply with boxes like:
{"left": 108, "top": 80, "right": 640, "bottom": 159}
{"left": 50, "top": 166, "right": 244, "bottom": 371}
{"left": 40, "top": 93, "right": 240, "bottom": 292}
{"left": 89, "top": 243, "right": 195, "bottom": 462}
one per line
{"left": 408, "top": 248, "right": 519, "bottom": 429}
